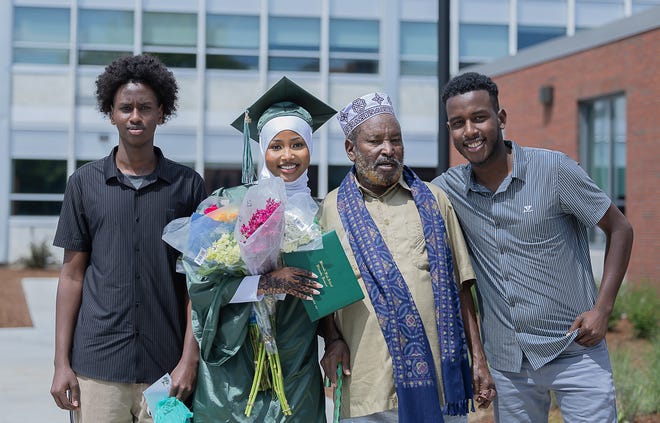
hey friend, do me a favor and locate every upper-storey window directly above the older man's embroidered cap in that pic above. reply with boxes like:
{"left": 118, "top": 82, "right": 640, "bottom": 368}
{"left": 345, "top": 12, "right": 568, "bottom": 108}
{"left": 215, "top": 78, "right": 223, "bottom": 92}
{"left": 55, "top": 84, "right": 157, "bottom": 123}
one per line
{"left": 330, "top": 19, "right": 379, "bottom": 73}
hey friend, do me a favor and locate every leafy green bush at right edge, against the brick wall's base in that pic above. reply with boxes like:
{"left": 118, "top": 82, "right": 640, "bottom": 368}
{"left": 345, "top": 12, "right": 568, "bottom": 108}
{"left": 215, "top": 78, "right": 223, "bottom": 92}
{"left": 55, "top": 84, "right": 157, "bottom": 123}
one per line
{"left": 623, "top": 284, "right": 660, "bottom": 339}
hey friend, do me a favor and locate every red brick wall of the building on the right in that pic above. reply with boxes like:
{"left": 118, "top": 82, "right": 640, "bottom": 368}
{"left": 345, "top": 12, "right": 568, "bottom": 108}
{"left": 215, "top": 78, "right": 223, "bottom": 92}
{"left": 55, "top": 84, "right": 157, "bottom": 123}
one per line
{"left": 450, "top": 30, "right": 660, "bottom": 286}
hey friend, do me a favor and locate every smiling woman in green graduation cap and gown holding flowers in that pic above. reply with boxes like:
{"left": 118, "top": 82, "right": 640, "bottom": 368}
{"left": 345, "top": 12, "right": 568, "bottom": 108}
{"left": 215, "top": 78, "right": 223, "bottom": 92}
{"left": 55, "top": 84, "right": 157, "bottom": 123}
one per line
{"left": 184, "top": 78, "right": 336, "bottom": 423}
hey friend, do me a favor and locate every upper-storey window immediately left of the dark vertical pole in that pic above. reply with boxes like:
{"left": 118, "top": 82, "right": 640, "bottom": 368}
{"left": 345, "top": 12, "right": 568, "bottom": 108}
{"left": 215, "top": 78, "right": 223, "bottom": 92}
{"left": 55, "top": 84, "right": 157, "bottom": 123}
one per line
{"left": 400, "top": 22, "right": 438, "bottom": 76}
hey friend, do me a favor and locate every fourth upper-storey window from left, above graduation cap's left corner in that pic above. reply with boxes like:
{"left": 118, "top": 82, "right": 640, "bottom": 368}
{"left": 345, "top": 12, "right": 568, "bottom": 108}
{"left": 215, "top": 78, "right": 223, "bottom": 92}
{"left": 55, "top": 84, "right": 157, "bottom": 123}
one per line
{"left": 206, "top": 15, "right": 259, "bottom": 70}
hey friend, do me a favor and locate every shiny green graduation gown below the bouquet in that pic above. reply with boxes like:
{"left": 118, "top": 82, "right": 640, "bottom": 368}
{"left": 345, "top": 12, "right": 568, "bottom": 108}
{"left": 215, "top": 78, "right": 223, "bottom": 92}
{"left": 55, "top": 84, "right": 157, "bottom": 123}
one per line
{"left": 184, "top": 263, "right": 326, "bottom": 423}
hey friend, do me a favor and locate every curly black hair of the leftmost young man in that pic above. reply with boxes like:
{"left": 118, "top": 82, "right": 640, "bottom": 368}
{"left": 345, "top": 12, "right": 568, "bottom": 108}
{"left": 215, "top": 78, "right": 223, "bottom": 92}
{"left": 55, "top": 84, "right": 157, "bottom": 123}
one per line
{"left": 96, "top": 54, "right": 179, "bottom": 122}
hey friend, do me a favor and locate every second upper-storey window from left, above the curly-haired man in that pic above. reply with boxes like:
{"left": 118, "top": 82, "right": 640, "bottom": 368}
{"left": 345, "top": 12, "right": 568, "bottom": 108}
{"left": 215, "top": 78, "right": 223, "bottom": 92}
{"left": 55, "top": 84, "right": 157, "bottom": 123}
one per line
{"left": 78, "top": 9, "right": 134, "bottom": 66}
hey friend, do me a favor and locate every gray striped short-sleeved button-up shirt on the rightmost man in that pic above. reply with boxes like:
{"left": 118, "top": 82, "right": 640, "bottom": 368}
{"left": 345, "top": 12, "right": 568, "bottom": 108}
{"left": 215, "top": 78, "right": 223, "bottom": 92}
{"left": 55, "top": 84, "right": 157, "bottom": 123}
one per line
{"left": 433, "top": 141, "right": 611, "bottom": 372}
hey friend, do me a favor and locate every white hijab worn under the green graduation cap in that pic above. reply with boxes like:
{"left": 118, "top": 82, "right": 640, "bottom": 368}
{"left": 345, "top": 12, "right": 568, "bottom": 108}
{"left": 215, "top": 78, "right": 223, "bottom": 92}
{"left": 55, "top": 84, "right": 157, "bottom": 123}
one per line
{"left": 259, "top": 116, "right": 312, "bottom": 197}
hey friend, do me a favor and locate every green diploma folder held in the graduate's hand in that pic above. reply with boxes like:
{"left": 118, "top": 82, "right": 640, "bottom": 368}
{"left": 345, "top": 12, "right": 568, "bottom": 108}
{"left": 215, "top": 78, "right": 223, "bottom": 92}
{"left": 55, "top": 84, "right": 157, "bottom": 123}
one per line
{"left": 282, "top": 231, "right": 364, "bottom": 321}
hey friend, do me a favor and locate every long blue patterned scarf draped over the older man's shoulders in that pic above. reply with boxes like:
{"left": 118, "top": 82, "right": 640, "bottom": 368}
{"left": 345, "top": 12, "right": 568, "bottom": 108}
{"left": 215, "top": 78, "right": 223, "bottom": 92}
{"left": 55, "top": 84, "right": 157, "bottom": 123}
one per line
{"left": 337, "top": 166, "right": 472, "bottom": 423}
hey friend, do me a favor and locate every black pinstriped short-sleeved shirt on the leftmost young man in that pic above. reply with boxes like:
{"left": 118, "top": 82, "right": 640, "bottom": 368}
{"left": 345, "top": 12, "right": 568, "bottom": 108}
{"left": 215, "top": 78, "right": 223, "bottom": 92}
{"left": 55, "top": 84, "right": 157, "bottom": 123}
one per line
{"left": 53, "top": 147, "right": 206, "bottom": 383}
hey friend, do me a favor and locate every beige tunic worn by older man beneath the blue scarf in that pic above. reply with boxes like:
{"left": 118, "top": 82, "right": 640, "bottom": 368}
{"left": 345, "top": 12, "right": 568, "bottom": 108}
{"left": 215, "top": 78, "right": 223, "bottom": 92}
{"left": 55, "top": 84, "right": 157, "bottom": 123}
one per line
{"left": 320, "top": 180, "right": 475, "bottom": 418}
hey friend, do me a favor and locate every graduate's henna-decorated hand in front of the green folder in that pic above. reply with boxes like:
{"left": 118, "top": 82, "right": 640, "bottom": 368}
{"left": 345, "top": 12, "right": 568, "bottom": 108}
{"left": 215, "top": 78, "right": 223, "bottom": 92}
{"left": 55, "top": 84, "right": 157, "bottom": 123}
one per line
{"left": 257, "top": 267, "right": 323, "bottom": 300}
